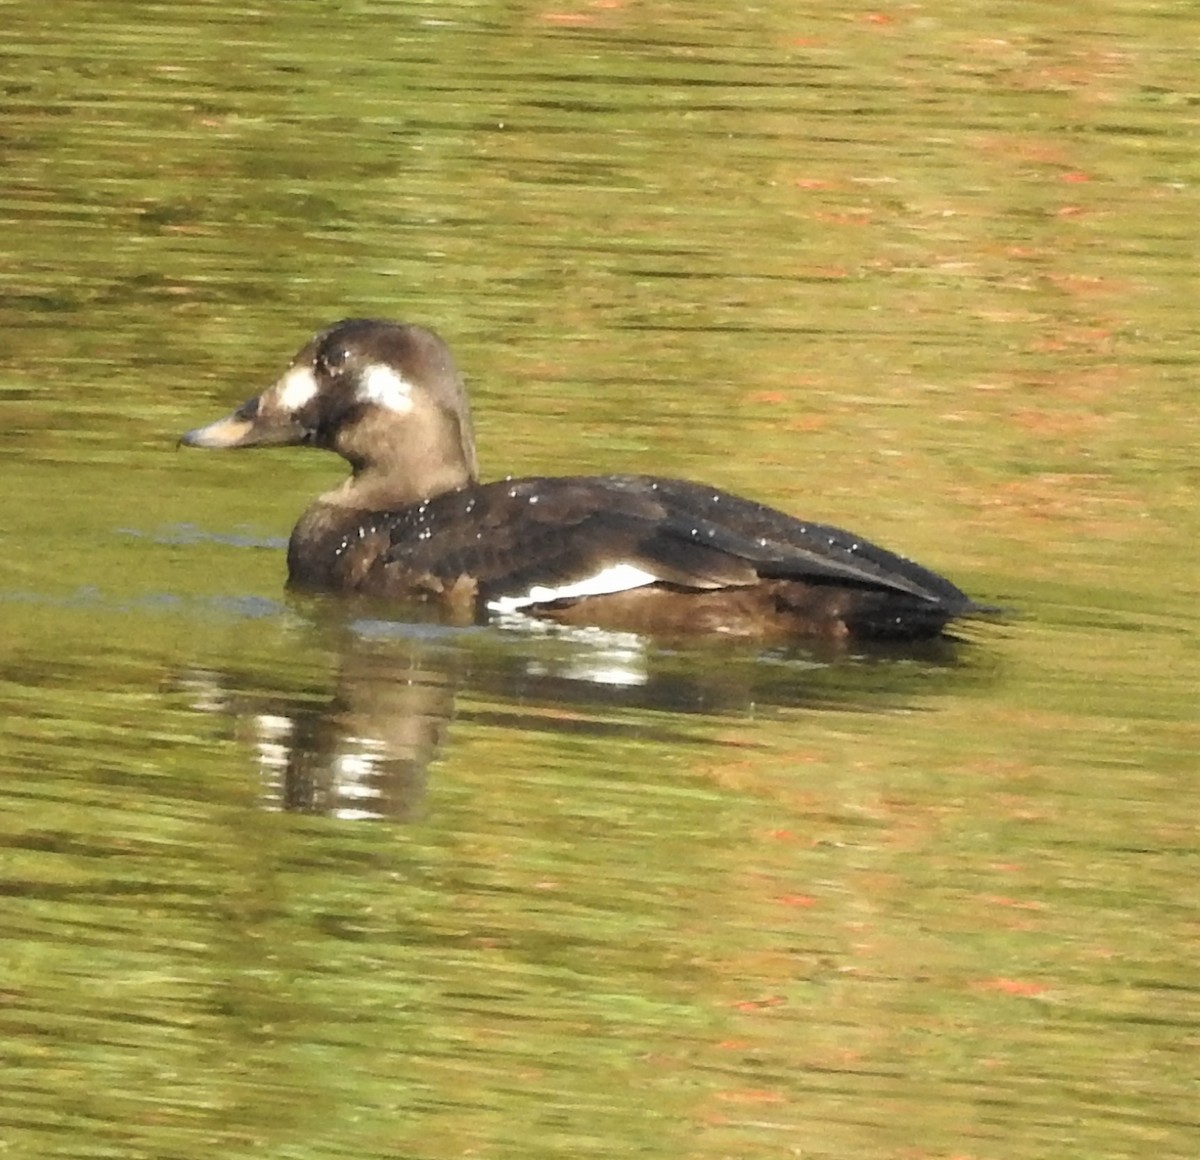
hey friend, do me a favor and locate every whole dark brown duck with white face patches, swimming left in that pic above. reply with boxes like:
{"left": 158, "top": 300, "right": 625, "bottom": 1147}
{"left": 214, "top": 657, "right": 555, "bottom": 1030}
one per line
{"left": 180, "top": 318, "right": 995, "bottom": 641}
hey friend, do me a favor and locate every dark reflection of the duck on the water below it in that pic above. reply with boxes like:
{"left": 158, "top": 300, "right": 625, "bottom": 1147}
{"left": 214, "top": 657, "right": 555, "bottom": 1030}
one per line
{"left": 176, "top": 597, "right": 992, "bottom": 819}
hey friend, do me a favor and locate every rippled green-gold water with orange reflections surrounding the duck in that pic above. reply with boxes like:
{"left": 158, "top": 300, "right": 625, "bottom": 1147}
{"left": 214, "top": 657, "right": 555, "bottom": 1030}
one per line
{"left": 0, "top": 0, "right": 1200, "bottom": 1160}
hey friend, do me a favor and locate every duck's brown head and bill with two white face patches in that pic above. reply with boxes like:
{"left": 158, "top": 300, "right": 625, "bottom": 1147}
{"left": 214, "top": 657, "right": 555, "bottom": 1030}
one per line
{"left": 180, "top": 318, "right": 478, "bottom": 504}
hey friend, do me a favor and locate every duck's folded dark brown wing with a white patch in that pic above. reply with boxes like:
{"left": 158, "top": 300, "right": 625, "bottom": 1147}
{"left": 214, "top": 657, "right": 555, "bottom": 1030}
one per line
{"left": 379, "top": 476, "right": 966, "bottom": 608}
